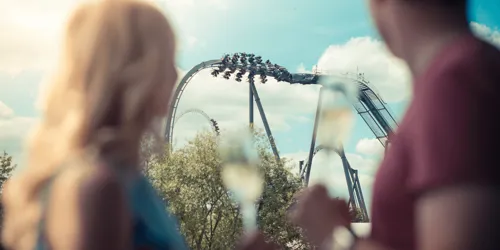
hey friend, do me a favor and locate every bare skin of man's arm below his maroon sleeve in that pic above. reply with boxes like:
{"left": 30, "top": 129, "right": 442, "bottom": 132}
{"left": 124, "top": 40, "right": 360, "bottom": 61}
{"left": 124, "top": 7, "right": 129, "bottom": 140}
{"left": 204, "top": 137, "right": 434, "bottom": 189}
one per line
{"left": 416, "top": 186, "right": 500, "bottom": 250}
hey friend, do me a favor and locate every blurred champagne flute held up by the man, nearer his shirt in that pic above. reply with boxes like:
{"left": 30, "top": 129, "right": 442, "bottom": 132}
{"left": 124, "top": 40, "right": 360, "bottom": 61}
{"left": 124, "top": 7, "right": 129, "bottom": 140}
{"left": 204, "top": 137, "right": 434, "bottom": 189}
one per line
{"left": 318, "top": 76, "right": 359, "bottom": 198}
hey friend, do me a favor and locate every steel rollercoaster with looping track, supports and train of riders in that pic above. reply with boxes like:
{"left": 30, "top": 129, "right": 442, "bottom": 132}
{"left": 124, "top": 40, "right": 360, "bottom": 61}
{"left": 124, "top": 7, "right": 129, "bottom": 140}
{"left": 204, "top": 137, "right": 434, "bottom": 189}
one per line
{"left": 165, "top": 53, "right": 397, "bottom": 222}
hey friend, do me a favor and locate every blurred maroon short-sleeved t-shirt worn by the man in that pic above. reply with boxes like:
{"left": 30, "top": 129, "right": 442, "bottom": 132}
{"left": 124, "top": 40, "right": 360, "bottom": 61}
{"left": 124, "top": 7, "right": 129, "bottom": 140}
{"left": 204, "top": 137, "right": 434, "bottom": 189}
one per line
{"left": 372, "top": 35, "right": 500, "bottom": 250}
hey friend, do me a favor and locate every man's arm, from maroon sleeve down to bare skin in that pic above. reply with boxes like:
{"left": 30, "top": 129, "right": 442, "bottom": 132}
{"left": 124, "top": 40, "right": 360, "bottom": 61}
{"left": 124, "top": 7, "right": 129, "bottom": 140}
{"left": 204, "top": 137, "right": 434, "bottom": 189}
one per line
{"left": 408, "top": 64, "right": 500, "bottom": 250}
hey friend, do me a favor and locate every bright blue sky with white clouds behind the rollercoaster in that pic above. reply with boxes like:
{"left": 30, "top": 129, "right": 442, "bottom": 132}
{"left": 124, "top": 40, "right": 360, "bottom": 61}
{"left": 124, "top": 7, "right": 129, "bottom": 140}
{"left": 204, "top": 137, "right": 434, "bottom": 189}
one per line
{"left": 0, "top": 0, "right": 500, "bottom": 211}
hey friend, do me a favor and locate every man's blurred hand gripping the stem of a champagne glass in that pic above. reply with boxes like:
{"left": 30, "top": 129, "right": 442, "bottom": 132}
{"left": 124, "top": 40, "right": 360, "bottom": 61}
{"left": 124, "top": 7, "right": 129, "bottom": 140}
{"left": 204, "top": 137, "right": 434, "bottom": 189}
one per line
{"left": 290, "top": 185, "right": 350, "bottom": 246}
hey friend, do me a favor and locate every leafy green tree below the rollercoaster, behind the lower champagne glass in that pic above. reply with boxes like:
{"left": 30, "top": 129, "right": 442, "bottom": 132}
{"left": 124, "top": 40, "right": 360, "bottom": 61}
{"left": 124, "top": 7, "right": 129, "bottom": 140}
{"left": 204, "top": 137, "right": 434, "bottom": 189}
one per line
{"left": 149, "top": 130, "right": 307, "bottom": 249}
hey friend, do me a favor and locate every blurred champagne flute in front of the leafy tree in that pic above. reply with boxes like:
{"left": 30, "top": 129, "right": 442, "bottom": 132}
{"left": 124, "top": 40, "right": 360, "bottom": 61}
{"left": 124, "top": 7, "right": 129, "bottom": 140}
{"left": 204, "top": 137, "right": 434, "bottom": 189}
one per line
{"left": 219, "top": 131, "right": 264, "bottom": 232}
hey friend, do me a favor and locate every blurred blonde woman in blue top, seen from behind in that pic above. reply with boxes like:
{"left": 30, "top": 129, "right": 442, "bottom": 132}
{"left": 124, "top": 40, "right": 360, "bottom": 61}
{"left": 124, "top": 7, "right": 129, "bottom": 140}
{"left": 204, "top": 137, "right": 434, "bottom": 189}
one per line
{"left": 2, "top": 0, "right": 186, "bottom": 250}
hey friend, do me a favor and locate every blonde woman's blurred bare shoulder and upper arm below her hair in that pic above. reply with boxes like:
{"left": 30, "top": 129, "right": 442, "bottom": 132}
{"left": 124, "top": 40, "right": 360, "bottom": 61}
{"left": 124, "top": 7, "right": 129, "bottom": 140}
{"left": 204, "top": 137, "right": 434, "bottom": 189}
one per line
{"left": 47, "top": 161, "right": 130, "bottom": 249}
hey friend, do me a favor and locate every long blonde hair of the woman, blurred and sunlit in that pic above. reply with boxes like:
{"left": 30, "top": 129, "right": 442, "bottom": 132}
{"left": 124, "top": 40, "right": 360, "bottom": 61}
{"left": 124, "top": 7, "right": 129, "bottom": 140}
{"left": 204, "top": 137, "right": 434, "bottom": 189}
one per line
{"left": 2, "top": 0, "right": 177, "bottom": 249}
